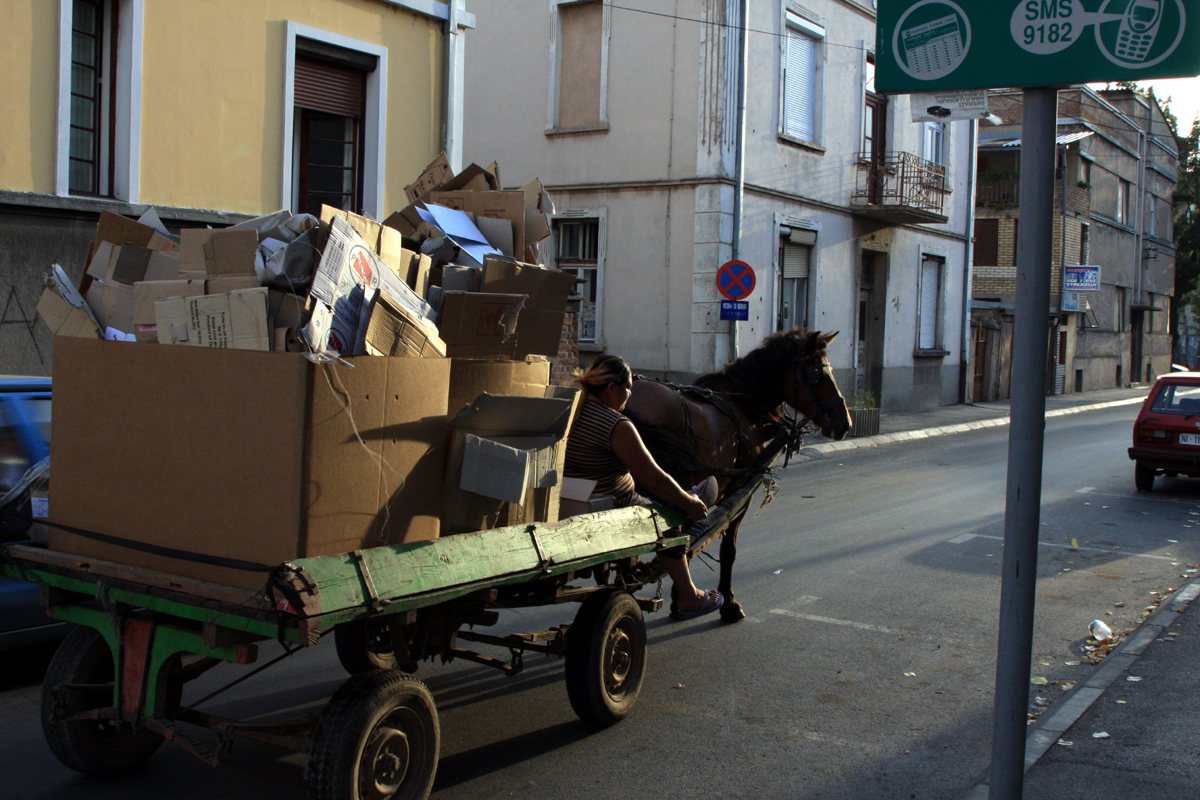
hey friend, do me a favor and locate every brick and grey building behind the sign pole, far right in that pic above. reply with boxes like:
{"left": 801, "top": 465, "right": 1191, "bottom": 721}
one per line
{"left": 971, "top": 88, "right": 1178, "bottom": 401}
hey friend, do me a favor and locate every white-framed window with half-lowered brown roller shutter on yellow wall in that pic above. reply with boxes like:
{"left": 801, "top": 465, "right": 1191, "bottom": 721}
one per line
{"left": 282, "top": 22, "right": 388, "bottom": 218}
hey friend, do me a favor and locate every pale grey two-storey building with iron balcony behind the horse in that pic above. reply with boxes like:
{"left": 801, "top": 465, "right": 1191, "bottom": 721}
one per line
{"left": 463, "top": 0, "right": 973, "bottom": 409}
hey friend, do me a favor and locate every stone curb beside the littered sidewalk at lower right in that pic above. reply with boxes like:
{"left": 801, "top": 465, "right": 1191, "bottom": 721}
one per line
{"left": 956, "top": 581, "right": 1200, "bottom": 800}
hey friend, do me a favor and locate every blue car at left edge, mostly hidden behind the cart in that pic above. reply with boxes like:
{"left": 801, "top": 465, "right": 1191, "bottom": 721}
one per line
{"left": 0, "top": 375, "right": 67, "bottom": 650}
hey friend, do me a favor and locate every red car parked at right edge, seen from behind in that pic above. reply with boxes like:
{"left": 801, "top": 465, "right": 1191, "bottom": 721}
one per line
{"left": 1129, "top": 372, "right": 1200, "bottom": 492}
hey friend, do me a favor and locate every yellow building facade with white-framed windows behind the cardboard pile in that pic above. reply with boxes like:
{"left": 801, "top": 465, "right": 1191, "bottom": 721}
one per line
{"left": 0, "top": 0, "right": 474, "bottom": 374}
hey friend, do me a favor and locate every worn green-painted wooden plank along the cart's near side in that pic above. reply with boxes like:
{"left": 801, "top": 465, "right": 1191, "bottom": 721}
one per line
{"left": 293, "top": 506, "right": 683, "bottom": 614}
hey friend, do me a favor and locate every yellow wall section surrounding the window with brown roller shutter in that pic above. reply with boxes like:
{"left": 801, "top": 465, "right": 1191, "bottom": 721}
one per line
{"left": 142, "top": 0, "right": 445, "bottom": 215}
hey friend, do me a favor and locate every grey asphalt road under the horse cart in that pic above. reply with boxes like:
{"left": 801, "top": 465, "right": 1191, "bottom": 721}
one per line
{"left": 0, "top": 407, "right": 1200, "bottom": 800}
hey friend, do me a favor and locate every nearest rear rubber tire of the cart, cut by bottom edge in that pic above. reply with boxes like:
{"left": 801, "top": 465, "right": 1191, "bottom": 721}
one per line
{"left": 304, "top": 669, "right": 442, "bottom": 800}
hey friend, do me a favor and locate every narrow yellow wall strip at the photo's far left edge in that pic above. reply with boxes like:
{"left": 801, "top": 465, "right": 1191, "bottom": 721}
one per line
{"left": 0, "top": 0, "right": 59, "bottom": 194}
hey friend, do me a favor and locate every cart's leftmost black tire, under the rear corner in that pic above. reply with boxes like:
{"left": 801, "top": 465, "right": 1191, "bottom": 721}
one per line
{"left": 42, "top": 626, "right": 163, "bottom": 777}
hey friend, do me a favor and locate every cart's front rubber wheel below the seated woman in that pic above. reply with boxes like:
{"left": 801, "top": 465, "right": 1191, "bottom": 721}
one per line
{"left": 565, "top": 591, "right": 646, "bottom": 728}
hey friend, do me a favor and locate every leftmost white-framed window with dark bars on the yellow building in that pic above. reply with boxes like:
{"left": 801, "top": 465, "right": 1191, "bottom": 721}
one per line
{"left": 54, "top": 0, "right": 144, "bottom": 203}
